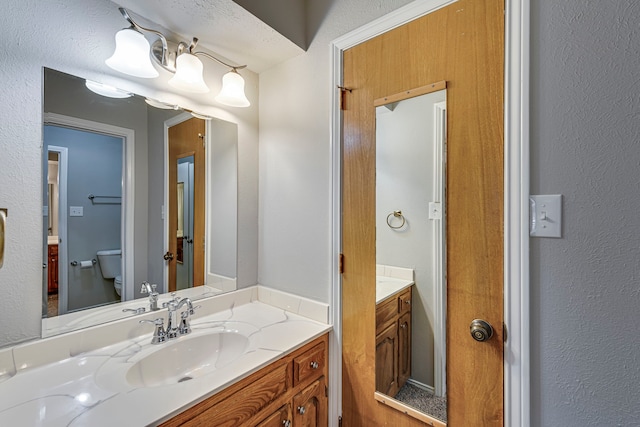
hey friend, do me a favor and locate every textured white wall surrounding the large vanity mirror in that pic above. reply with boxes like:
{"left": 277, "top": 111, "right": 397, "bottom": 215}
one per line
{"left": 0, "top": 0, "right": 259, "bottom": 347}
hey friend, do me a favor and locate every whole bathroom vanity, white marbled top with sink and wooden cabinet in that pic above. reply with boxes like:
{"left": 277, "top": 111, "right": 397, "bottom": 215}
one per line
{"left": 0, "top": 286, "right": 331, "bottom": 427}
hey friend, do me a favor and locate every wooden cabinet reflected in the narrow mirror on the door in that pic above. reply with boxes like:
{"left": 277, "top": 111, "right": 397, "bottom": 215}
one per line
{"left": 376, "top": 287, "right": 411, "bottom": 397}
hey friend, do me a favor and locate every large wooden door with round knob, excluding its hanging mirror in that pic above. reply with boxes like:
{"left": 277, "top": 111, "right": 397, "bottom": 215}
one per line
{"left": 342, "top": 0, "right": 504, "bottom": 427}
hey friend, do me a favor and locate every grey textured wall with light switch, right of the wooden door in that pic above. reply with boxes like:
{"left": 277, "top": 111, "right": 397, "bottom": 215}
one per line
{"left": 531, "top": 0, "right": 640, "bottom": 427}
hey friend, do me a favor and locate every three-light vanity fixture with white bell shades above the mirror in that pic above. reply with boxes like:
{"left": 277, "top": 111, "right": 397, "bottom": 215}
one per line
{"left": 106, "top": 7, "right": 251, "bottom": 107}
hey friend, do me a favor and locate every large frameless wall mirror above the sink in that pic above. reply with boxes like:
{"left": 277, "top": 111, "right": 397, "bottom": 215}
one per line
{"left": 42, "top": 68, "right": 238, "bottom": 337}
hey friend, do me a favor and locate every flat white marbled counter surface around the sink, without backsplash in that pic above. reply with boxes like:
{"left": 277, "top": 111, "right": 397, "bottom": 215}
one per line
{"left": 0, "top": 291, "right": 331, "bottom": 427}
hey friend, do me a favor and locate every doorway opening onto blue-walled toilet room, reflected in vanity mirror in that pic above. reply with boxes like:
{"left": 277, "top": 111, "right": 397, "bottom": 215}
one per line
{"left": 43, "top": 125, "right": 124, "bottom": 317}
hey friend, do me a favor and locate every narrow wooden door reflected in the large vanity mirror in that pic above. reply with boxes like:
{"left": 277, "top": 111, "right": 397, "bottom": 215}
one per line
{"left": 167, "top": 117, "right": 205, "bottom": 292}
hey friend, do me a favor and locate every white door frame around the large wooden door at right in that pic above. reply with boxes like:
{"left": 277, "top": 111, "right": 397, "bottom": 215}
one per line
{"left": 329, "top": 0, "right": 530, "bottom": 427}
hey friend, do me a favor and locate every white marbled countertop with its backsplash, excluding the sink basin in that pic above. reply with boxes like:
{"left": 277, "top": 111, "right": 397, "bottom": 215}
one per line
{"left": 0, "top": 286, "right": 331, "bottom": 426}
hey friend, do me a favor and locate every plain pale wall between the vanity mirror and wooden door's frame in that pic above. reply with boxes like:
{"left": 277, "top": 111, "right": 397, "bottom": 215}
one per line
{"left": 258, "top": 0, "right": 409, "bottom": 302}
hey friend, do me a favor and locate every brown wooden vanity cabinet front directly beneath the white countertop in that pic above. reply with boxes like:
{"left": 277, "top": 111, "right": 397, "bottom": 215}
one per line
{"left": 162, "top": 334, "right": 329, "bottom": 427}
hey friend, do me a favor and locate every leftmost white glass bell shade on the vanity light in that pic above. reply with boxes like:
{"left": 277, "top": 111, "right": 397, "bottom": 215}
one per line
{"left": 105, "top": 28, "right": 159, "bottom": 79}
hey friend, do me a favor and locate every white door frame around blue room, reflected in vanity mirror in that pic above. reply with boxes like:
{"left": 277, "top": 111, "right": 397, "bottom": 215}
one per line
{"left": 43, "top": 113, "right": 136, "bottom": 301}
